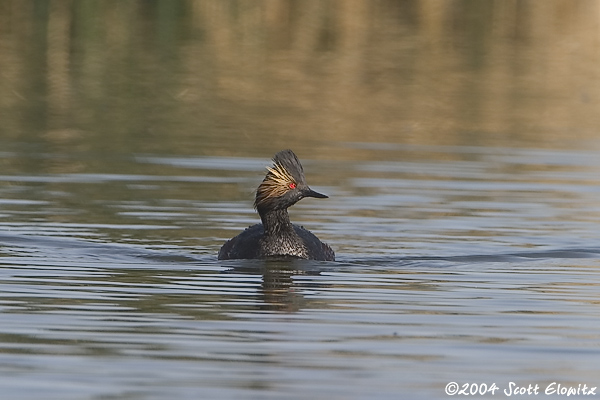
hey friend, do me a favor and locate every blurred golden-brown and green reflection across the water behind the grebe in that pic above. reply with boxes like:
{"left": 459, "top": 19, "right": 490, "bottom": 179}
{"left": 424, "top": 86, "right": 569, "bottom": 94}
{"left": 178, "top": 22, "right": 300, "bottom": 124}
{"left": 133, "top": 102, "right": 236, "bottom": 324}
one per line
{"left": 0, "top": 0, "right": 600, "bottom": 162}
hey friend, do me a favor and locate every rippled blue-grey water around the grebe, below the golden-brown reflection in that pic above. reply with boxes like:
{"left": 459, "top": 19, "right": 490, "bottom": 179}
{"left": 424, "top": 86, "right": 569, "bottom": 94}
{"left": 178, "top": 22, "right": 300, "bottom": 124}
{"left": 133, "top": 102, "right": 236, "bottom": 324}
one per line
{"left": 0, "top": 143, "right": 600, "bottom": 399}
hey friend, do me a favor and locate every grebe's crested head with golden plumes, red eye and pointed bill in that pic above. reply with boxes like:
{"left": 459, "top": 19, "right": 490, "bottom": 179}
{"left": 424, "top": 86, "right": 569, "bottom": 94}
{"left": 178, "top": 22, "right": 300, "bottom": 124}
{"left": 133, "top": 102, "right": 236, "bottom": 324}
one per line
{"left": 254, "top": 150, "right": 328, "bottom": 214}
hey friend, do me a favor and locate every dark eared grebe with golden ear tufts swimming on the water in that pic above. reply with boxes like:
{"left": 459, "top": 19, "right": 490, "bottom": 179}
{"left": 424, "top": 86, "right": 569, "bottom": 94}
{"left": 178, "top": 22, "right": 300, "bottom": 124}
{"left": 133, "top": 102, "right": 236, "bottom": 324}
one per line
{"left": 219, "top": 150, "right": 335, "bottom": 261}
